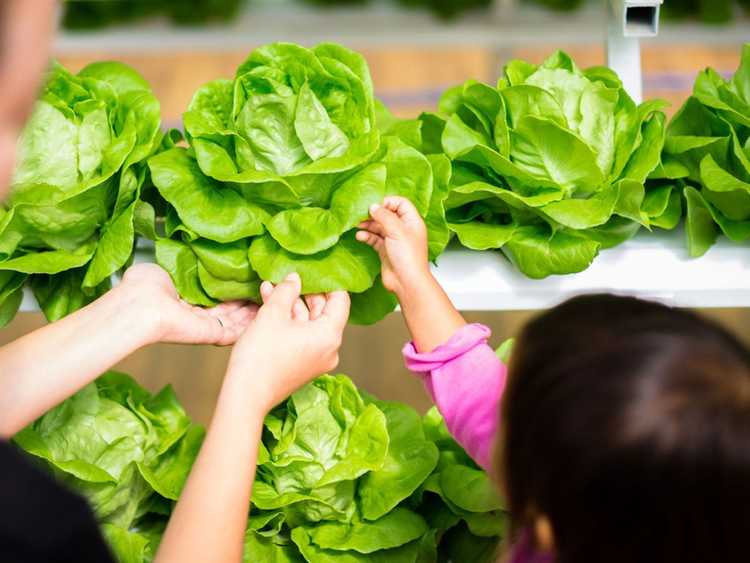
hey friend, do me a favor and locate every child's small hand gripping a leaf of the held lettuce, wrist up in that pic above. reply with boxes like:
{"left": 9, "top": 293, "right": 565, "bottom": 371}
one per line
{"left": 357, "top": 196, "right": 430, "bottom": 299}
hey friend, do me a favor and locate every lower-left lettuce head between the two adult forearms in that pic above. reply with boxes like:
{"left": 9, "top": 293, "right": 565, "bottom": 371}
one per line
{"left": 13, "top": 372, "right": 204, "bottom": 563}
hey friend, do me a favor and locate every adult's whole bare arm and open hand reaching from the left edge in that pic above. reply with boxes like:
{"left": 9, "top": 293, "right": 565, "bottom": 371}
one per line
{"left": 0, "top": 264, "right": 254, "bottom": 437}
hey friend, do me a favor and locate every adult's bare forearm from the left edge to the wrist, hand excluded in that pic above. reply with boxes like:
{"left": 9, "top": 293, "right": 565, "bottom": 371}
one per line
{"left": 0, "top": 289, "right": 154, "bottom": 437}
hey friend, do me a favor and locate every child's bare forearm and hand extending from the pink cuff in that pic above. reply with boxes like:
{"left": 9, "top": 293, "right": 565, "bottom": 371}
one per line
{"left": 357, "top": 197, "right": 466, "bottom": 352}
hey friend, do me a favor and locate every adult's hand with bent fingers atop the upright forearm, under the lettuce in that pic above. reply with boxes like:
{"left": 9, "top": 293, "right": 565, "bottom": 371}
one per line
{"left": 229, "top": 274, "right": 349, "bottom": 410}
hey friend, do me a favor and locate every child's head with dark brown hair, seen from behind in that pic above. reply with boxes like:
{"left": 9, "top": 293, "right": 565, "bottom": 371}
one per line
{"left": 496, "top": 295, "right": 750, "bottom": 563}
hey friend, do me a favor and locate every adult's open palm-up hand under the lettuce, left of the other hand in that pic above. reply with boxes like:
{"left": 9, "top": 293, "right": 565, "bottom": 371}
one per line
{"left": 114, "top": 264, "right": 258, "bottom": 346}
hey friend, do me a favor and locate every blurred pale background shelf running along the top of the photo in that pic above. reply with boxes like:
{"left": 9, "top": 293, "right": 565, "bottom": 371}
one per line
{"left": 55, "top": 0, "right": 750, "bottom": 55}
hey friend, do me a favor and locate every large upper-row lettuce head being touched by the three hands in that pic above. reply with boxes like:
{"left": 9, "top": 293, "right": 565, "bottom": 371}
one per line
{"left": 149, "top": 43, "right": 447, "bottom": 323}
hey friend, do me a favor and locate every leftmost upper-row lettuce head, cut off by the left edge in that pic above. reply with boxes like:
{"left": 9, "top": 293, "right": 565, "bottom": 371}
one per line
{"left": 0, "top": 62, "right": 162, "bottom": 324}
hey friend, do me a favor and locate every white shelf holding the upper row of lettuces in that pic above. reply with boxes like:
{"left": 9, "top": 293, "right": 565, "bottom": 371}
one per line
{"left": 14, "top": 232, "right": 750, "bottom": 312}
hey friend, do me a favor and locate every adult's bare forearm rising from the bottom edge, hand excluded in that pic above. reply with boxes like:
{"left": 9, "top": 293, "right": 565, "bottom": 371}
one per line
{"left": 156, "top": 367, "right": 267, "bottom": 563}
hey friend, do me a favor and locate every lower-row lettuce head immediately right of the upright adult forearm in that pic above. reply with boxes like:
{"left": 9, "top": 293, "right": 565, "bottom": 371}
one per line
{"left": 246, "top": 376, "right": 446, "bottom": 563}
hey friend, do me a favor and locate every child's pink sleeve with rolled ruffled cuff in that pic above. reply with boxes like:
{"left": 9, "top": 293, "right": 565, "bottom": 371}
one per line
{"left": 403, "top": 324, "right": 507, "bottom": 469}
